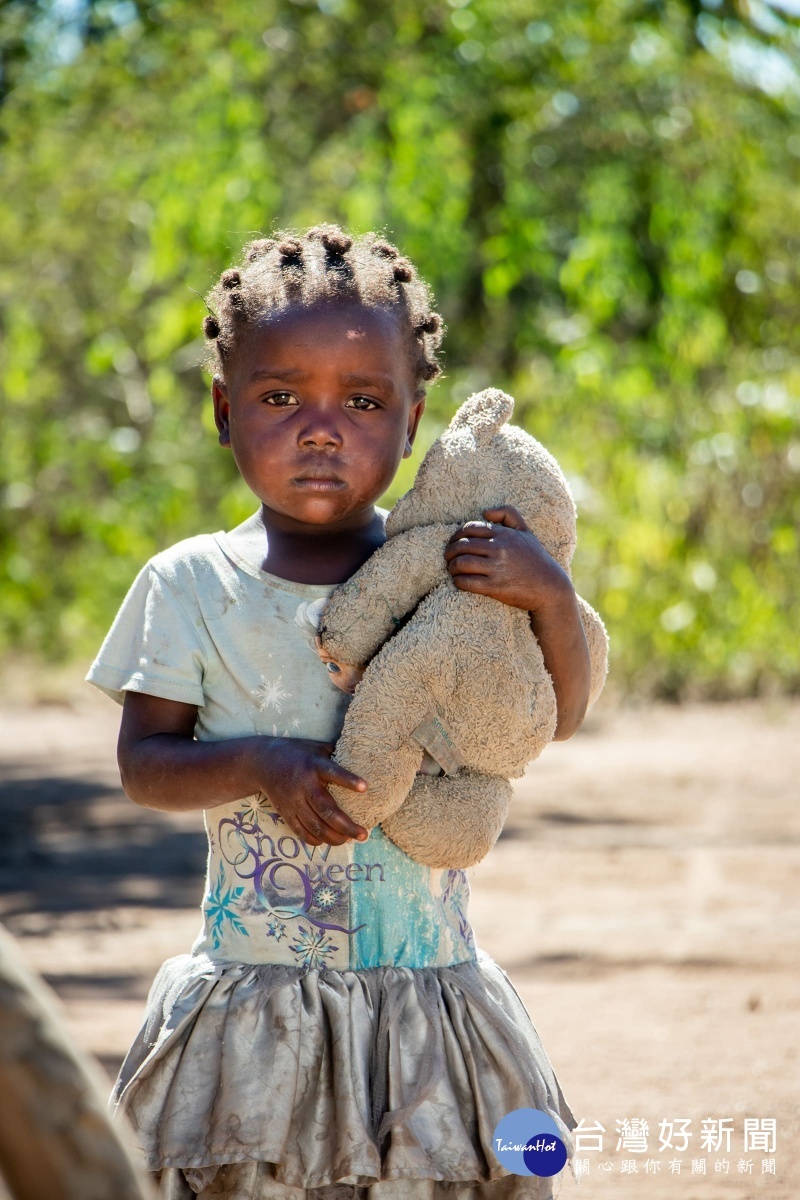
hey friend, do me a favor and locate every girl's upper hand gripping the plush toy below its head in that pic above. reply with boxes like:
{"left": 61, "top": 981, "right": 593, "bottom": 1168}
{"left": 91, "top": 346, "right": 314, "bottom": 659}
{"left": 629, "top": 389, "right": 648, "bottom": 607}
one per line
{"left": 445, "top": 504, "right": 572, "bottom": 613}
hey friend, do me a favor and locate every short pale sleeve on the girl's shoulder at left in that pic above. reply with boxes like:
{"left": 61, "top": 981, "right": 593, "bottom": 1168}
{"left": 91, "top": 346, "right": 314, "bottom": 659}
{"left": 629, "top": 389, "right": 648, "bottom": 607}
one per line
{"left": 86, "top": 563, "right": 206, "bottom": 708}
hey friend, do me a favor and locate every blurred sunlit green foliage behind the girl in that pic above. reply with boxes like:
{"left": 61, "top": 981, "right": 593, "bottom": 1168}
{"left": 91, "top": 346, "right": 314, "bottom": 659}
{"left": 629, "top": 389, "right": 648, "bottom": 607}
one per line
{"left": 0, "top": 0, "right": 800, "bottom": 698}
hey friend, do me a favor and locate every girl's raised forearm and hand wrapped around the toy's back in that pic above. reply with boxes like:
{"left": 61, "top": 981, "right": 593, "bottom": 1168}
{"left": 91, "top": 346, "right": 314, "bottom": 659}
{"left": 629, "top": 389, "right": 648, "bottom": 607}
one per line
{"left": 445, "top": 505, "right": 591, "bottom": 742}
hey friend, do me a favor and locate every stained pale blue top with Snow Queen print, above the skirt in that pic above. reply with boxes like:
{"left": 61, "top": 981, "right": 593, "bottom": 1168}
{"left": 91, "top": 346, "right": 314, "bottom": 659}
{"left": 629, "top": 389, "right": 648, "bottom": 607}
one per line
{"left": 86, "top": 533, "right": 476, "bottom": 971}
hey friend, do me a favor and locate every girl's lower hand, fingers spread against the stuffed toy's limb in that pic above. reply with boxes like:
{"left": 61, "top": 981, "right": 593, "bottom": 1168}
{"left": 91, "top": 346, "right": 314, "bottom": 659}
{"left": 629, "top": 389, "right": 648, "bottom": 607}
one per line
{"left": 258, "top": 738, "right": 369, "bottom": 846}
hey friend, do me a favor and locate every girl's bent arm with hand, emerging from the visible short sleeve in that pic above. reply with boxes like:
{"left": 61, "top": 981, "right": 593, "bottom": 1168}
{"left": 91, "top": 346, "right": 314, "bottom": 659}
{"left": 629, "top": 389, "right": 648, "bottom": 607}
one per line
{"left": 118, "top": 691, "right": 367, "bottom": 846}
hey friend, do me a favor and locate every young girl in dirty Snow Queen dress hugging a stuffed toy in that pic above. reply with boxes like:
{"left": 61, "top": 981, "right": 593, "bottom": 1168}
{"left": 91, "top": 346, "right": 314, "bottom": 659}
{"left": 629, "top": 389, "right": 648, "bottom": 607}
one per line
{"left": 88, "top": 226, "right": 589, "bottom": 1200}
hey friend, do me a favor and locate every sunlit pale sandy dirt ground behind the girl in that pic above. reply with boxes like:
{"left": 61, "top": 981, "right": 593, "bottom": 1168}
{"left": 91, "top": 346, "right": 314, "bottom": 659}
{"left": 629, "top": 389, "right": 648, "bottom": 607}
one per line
{"left": 0, "top": 696, "right": 800, "bottom": 1200}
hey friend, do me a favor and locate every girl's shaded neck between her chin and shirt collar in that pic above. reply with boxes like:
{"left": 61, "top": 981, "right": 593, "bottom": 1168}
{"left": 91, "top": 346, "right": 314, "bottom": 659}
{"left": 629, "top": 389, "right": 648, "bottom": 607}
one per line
{"left": 228, "top": 506, "right": 386, "bottom": 583}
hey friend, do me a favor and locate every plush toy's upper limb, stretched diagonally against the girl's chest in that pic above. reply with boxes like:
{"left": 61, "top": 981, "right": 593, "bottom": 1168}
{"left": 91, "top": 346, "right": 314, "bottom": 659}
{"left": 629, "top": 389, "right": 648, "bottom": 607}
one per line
{"left": 319, "top": 524, "right": 458, "bottom": 666}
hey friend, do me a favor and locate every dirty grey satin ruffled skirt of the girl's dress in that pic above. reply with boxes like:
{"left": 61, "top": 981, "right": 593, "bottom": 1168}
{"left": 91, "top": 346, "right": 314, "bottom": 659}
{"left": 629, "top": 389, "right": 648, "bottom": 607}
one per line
{"left": 114, "top": 950, "right": 577, "bottom": 1200}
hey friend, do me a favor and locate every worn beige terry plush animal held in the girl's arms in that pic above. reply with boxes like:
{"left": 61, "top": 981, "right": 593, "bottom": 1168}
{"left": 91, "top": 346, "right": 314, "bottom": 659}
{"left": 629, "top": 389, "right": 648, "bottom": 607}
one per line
{"left": 317, "top": 389, "right": 608, "bottom": 868}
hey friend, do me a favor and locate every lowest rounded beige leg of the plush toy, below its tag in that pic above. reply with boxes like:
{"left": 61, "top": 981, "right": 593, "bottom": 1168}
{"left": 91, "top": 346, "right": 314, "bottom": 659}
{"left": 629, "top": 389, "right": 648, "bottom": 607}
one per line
{"left": 383, "top": 768, "right": 512, "bottom": 869}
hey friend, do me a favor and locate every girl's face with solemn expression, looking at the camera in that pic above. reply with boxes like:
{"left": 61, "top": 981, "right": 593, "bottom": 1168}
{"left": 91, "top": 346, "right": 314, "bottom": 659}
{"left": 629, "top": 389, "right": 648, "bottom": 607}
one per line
{"left": 213, "top": 304, "right": 425, "bottom": 530}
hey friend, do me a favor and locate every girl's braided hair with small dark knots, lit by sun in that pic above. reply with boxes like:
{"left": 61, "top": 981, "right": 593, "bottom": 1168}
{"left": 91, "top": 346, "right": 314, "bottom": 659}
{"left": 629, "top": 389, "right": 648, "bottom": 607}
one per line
{"left": 203, "top": 224, "right": 444, "bottom": 391}
